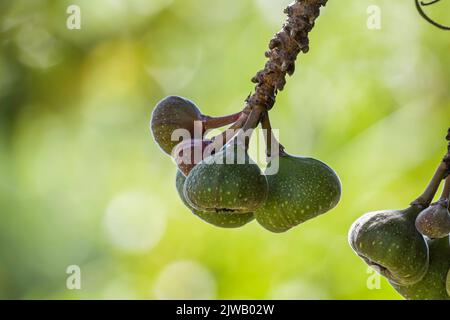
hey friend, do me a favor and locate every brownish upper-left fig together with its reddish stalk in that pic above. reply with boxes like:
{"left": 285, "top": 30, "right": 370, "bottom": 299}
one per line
{"left": 150, "top": 96, "right": 241, "bottom": 154}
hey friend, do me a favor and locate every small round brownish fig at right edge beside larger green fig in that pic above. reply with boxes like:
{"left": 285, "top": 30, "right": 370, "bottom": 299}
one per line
{"left": 416, "top": 200, "right": 450, "bottom": 239}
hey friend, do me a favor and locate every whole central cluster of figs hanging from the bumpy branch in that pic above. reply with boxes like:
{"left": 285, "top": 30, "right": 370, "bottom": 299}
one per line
{"left": 150, "top": 96, "right": 341, "bottom": 233}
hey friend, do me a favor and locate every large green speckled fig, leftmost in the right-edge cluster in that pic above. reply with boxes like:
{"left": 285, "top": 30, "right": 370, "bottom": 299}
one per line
{"left": 349, "top": 206, "right": 429, "bottom": 285}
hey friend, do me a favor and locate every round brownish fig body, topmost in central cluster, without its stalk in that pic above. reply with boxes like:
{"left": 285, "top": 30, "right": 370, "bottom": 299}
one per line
{"left": 150, "top": 96, "right": 204, "bottom": 155}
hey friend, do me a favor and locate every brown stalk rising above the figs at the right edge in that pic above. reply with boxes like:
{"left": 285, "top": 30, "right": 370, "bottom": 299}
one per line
{"left": 411, "top": 128, "right": 450, "bottom": 208}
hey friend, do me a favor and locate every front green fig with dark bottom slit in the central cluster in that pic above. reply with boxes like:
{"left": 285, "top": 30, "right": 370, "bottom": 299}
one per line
{"left": 184, "top": 145, "right": 268, "bottom": 213}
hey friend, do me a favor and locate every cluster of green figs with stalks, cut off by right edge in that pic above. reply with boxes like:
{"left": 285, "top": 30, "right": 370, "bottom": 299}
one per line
{"left": 349, "top": 129, "right": 450, "bottom": 300}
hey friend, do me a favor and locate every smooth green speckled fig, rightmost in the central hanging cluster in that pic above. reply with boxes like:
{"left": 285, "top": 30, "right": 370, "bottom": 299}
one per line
{"left": 255, "top": 155, "right": 341, "bottom": 233}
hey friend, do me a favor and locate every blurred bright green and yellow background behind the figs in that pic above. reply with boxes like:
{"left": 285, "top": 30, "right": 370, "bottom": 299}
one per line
{"left": 0, "top": 0, "right": 450, "bottom": 299}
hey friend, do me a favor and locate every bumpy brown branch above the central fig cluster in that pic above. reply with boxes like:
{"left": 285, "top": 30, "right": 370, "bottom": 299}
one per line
{"left": 247, "top": 0, "right": 328, "bottom": 110}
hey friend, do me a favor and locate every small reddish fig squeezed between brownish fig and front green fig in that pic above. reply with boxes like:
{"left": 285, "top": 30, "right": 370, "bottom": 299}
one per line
{"left": 172, "top": 139, "right": 212, "bottom": 176}
